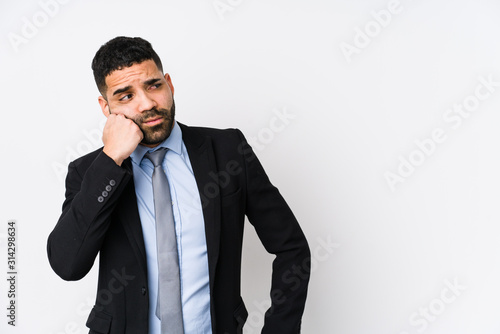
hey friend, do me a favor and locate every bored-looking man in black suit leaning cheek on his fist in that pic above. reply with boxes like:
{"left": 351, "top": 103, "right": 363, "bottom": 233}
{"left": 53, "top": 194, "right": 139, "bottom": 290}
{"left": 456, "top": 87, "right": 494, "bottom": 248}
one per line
{"left": 47, "top": 37, "right": 310, "bottom": 334}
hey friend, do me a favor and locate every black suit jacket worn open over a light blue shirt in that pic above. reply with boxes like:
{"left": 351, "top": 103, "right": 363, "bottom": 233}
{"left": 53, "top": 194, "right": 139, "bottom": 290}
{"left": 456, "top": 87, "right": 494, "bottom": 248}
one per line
{"left": 47, "top": 124, "right": 310, "bottom": 334}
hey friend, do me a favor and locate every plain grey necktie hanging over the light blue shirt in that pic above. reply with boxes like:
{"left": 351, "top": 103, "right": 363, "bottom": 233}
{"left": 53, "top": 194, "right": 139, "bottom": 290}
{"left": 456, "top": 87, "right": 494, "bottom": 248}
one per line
{"left": 145, "top": 147, "right": 184, "bottom": 334}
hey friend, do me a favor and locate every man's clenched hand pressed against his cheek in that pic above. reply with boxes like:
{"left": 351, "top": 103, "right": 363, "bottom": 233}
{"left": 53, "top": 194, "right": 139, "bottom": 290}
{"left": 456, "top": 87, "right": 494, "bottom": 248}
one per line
{"left": 102, "top": 114, "right": 144, "bottom": 166}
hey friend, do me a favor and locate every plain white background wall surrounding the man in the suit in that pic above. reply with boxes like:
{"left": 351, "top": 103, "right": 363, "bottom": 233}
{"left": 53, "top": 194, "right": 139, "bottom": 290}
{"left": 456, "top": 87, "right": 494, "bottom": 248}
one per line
{"left": 0, "top": 0, "right": 500, "bottom": 334}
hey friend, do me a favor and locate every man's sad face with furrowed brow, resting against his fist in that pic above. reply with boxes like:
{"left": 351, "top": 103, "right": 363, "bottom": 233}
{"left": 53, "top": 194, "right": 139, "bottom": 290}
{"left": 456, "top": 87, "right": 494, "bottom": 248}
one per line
{"left": 99, "top": 60, "right": 175, "bottom": 147}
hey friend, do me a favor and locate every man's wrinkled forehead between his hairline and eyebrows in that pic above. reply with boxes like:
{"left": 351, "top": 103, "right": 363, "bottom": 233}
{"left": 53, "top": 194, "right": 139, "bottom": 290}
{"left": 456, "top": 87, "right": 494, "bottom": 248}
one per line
{"left": 106, "top": 59, "right": 163, "bottom": 91}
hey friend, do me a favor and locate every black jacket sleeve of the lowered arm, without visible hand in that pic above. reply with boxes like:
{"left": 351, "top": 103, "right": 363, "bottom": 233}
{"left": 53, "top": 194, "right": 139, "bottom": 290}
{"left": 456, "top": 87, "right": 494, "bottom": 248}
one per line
{"left": 239, "top": 132, "right": 311, "bottom": 334}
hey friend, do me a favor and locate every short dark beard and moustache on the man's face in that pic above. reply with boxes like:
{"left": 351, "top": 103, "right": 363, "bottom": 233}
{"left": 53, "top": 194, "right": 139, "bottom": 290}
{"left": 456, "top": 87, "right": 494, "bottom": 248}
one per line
{"left": 132, "top": 100, "right": 175, "bottom": 145}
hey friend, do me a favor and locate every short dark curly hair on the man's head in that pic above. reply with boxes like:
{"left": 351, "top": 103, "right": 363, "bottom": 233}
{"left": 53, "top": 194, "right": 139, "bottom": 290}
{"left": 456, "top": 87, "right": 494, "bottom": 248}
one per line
{"left": 92, "top": 36, "right": 163, "bottom": 98}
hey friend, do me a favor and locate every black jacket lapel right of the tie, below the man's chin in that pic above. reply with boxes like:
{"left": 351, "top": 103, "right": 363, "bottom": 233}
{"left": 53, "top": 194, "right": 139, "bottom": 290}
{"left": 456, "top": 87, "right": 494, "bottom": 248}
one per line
{"left": 178, "top": 123, "right": 221, "bottom": 291}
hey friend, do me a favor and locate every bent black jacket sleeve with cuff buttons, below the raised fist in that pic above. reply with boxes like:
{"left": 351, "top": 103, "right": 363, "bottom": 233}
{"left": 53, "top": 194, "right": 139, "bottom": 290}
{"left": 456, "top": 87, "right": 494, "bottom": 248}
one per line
{"left": 47, "top": 151, "right": 132, "bottom": 280}
